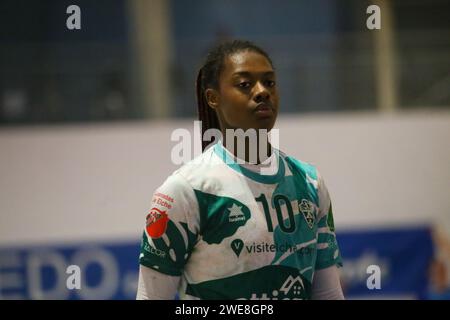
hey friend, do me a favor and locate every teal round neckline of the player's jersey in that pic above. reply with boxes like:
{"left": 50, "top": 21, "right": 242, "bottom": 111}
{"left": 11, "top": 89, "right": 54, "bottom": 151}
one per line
{"left": 214, "top": 141, "right": 285, "bottom": 184}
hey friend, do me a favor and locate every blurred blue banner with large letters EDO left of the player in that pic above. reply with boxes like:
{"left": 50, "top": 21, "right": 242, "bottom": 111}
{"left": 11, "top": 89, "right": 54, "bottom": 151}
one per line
{"left": 0, "top": 241, "right": 139, "bottom": 300}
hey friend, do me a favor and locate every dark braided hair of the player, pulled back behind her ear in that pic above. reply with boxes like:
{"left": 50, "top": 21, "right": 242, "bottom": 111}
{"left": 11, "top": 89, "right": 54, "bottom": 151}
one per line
{"left": 196, "top": 40, "right": 273, "bottom": 151}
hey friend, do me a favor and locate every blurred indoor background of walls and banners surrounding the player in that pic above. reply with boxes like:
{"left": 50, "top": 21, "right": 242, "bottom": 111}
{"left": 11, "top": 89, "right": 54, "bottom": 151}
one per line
{"left": 0, "top": 0, "right": 450, "bottom": 299}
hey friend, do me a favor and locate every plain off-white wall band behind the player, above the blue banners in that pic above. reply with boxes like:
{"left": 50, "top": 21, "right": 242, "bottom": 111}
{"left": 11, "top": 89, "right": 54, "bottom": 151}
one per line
{"left": 0, "top": 112, "right": 450, "bottom": 246}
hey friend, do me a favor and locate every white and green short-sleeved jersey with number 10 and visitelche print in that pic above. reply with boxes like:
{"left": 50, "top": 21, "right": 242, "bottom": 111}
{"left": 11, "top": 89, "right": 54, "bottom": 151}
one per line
{"left": 140, "top": 142, "right": 342, "bottom": 299}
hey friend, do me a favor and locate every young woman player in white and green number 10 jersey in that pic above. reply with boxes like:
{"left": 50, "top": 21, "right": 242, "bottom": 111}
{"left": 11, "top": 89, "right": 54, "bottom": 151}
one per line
{"left": 137, "top": 41, "right": 343, "bottom": 300}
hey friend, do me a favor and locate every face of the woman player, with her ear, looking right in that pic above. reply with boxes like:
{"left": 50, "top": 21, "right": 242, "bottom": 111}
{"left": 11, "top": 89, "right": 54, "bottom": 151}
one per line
{"left": 206, "top": 51, "right": 278, "bottom": 131}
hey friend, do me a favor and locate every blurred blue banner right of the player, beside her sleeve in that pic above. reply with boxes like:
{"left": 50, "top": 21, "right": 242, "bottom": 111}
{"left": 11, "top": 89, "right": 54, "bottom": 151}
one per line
{"left": 337, "top": 227, "right": 433, "bottom": 299}
